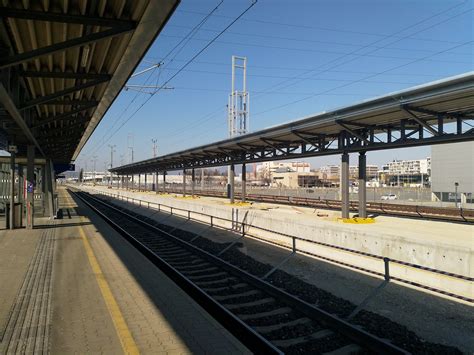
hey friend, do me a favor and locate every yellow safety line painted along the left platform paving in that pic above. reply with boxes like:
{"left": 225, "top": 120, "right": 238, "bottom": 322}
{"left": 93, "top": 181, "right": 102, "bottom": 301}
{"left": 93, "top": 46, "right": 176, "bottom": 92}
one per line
{"left": 79, "top": 218, "right": 140, "bottom": 354}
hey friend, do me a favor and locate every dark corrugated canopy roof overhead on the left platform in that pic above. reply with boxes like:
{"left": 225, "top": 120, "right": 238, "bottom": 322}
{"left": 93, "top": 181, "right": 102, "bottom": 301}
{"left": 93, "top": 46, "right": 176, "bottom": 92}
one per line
{"left": 0, "top": 0, "right": 179, "bottom": 163}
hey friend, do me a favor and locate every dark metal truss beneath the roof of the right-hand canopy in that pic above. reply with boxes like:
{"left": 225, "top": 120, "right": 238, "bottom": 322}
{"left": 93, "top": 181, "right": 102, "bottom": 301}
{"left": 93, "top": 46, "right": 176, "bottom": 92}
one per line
{"left": 113, "top": 105, "right": 474, "bottom": 174}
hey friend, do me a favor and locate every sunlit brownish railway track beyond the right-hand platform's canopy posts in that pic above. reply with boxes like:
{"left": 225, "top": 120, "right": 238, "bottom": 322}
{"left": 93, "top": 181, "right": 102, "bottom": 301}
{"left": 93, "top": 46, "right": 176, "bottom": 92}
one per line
{"left": 146, "top": 189, "right": 474, "bottom": 223}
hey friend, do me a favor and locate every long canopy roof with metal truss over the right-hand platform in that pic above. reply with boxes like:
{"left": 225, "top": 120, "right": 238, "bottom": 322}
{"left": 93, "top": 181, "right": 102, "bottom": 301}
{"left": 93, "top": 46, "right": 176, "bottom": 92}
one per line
{"left": 111, "top": 72, "right": 474, "bottom": 174}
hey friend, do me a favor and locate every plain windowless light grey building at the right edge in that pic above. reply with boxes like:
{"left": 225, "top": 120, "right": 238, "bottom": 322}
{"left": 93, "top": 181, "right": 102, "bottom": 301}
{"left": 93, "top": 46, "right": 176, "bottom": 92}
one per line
{"left": 431, "top": 142, "right": 474, "bottom": 203}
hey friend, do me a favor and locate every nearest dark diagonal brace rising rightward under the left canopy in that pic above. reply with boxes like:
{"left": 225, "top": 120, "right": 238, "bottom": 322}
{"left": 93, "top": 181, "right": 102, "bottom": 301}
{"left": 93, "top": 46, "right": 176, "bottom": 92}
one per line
{"left": 0, "top": 27, "right": 135, "bottom": 69}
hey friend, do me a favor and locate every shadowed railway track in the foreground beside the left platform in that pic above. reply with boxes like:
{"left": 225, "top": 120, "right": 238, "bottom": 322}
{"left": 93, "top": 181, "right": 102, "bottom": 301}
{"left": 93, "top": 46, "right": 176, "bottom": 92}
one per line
{"left": 73, "top": 192, "right": 407, "bottom": 355}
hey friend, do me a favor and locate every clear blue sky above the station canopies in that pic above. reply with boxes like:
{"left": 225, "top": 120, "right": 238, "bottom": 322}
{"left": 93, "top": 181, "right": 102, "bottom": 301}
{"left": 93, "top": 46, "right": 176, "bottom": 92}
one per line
{"left": 76, "top": 0, "right": 474, "bottom": 170}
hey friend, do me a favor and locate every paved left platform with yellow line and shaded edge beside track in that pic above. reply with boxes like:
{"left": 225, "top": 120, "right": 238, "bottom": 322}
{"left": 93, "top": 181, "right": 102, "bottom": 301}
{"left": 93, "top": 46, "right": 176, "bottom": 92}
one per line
{"left": 0, "top": 188, "right": 248, "bottom": 354}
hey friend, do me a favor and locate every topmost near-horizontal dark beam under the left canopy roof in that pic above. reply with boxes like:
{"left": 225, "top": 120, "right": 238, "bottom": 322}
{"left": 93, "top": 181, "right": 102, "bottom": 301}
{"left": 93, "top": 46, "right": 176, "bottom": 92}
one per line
{"left": 0, "top": 7, "right": 136, "bottom": 27}
